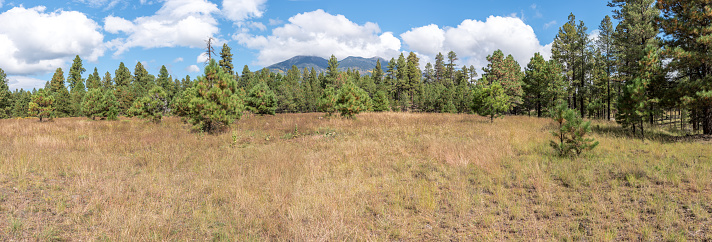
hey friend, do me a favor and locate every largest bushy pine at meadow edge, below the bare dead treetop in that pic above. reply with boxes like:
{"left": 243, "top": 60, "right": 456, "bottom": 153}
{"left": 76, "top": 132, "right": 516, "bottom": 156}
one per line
{"left": 174, "top": 60, "right": 244, "bottom": 133}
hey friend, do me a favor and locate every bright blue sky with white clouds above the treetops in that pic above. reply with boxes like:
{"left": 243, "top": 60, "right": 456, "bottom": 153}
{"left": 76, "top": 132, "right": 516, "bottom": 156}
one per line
{"left": 0, "top": 0, "right": 612, "bottom": 90}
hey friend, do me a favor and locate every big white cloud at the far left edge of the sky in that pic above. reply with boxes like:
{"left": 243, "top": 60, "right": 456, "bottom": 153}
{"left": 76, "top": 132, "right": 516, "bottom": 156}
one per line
{"left": 0, "top": 6, "right": 105, "bottom": 75}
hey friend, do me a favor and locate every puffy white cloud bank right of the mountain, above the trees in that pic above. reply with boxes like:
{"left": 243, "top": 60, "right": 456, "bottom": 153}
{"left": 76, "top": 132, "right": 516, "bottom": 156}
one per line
{"left": 401, "top": 16, "right": 551, "bottom": 71}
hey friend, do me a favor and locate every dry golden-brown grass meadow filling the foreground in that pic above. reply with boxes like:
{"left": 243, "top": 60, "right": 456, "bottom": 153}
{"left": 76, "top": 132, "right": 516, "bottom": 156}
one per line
{"left": 0, "top": 113, "right": 712, "bottom": 241}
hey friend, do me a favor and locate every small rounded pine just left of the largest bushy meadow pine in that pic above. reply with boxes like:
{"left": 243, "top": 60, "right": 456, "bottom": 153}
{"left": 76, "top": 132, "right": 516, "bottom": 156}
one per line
{"left": 128, "top": 86, "right": 168, "bottom": 123}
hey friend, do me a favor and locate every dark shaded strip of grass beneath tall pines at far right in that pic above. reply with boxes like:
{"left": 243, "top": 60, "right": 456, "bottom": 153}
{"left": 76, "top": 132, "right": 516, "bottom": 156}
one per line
{"left": 591, "top": 125, "right": 712, "bottom": 143}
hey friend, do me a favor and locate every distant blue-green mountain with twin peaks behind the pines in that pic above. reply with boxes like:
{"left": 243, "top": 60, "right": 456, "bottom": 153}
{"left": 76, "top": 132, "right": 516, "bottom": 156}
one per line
{"left": 267, "top": 56, "right": 388, "bottom": 74}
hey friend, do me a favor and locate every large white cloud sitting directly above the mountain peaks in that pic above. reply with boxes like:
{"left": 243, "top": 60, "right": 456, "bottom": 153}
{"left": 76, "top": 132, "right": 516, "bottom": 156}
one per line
{"left": 233, "top": 9, "right": 401, "bottom": 66}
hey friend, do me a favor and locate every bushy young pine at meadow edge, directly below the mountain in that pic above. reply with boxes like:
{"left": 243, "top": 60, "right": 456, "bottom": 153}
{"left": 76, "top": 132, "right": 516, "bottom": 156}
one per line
{"left": 336, "top": 79, "right": 371, "bottom": 119}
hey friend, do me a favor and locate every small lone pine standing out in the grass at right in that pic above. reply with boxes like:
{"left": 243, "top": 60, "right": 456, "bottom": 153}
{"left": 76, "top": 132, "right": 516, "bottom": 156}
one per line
{"left": 550, "top": 102, "right": 598, "bottom": 156}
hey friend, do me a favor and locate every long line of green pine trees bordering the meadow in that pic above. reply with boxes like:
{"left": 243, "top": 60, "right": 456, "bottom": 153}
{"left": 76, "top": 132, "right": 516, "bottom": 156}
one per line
{"left": 0, "top": 0, "right": 712, "bottom": 134}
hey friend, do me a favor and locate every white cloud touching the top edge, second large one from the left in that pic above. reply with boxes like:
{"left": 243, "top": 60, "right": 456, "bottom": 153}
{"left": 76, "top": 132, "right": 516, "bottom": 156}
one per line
{"left": 104, "top": 0, "right": 219, "bottom": 55}
